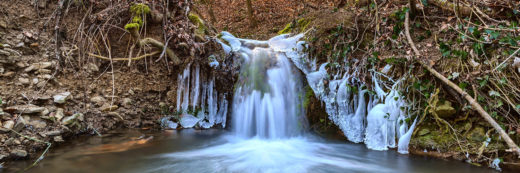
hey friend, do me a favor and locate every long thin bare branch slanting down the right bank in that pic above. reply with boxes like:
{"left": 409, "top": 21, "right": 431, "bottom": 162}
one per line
{"left": 404, "top": 7, "right": 520, "bottom": 158}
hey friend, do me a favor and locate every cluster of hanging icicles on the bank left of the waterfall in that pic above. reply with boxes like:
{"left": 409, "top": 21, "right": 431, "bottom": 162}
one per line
{"left": 176, "top": 64, "right": 228, "bottom": 128}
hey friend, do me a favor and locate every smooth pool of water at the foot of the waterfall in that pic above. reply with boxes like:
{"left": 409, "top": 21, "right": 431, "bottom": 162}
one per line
{"left": 6, "top": 129, "right": 493, "bottom": 173}
